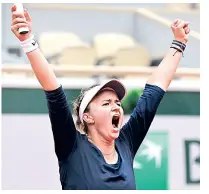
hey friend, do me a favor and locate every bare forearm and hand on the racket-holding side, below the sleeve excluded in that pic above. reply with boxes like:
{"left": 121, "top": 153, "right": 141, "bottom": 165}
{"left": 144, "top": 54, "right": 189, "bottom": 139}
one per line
{"left": 11, "top": 5, "right": 60, "bottom": 91}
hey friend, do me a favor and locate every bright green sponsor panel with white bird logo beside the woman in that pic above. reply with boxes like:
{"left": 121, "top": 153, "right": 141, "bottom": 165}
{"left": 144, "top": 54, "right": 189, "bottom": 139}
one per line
{"left": 134, "top": 131, "right": 169, "bottom": 190}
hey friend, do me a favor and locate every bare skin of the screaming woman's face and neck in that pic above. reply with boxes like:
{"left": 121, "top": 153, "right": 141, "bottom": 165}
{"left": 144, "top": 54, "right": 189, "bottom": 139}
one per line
{"left": 84, "top": 89, "right": 124, "bottom": 163}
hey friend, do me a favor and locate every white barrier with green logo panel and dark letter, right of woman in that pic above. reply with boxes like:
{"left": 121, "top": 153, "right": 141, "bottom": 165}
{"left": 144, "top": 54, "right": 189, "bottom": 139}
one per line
{"left": 125, "top": 116, "right": 200, "bottom": 190}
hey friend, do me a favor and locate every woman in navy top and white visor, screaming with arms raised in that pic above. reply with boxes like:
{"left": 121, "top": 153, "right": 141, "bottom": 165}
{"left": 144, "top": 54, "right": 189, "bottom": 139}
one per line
{"left": 11, "top": 6, "right": 190, "bottom": 190}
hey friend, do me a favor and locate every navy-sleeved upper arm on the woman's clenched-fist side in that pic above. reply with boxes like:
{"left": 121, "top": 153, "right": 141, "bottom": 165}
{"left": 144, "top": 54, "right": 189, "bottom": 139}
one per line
{"left": 121, "top": 84, "right": 165, "bottom": 155}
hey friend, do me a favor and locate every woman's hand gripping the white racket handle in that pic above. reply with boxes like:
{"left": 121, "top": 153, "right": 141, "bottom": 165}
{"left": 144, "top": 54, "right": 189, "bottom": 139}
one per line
{"left": 11, "top": 5, "right": 32, "bottom": 41}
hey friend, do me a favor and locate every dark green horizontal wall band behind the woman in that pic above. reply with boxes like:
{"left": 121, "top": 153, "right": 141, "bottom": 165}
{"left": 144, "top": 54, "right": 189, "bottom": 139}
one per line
{"left": 2, "top": 88, "right": 200, "bottom": 115}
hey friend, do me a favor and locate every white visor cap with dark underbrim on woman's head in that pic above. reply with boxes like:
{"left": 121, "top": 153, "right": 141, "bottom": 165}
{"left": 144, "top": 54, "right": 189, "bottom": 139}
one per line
{"left": 79, "top": 79, "right": 126, "bottom": 124}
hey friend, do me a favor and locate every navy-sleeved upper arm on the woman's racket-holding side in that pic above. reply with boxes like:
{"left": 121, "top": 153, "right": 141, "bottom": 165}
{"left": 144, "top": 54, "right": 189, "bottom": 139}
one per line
{"left": 45, "top": 86, "right": 76, "bottom": 160}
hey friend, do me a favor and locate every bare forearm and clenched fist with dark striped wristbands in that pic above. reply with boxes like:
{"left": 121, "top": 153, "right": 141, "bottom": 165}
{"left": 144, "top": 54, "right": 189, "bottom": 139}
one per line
{"left": 147, "top": 19, "right": 190, "bottom": 91}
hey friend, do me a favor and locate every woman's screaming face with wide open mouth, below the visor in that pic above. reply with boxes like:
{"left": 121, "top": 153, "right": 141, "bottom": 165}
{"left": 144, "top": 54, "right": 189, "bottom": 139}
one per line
{"left": 85, "top": 89, "right": 123, "bottom": 140}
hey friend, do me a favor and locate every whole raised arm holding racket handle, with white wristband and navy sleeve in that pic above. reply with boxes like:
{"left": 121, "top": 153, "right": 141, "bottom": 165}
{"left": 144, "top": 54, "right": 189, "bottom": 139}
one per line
{"left": 11, "top": 5, "right": 76, "bottom": 161}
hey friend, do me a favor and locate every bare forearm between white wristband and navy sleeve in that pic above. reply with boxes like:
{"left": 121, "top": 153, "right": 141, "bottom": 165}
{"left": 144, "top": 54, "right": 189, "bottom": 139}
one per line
{"left": 27, "top": 48, "right": 60, "bottom": 91}
